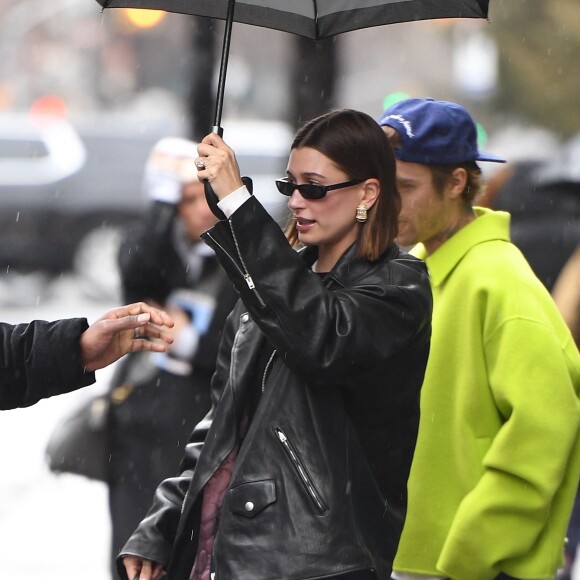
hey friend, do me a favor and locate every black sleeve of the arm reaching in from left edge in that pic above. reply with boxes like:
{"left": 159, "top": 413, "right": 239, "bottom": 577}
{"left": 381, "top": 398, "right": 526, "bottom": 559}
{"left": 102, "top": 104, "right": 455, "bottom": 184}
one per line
{"left": 0, "top": 318, "right": 95, "bottom": 409}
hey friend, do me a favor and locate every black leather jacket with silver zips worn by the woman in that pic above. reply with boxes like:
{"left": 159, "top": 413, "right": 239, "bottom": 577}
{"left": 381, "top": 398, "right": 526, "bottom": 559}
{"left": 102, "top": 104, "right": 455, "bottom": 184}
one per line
{"left": 122, "top": 198, "right": 432, "bottom": 580}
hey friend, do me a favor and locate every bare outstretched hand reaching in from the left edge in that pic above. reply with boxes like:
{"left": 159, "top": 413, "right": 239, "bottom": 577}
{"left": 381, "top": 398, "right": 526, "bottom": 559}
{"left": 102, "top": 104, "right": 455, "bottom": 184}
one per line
{"left": 80, "top": 302, "right": 173, "bottom": 372}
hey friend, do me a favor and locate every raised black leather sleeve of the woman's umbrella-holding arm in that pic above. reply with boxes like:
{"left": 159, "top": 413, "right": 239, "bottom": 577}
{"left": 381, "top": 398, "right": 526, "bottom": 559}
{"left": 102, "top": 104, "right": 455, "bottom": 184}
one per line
{"left": 203, "top": 197, "right": 431, "bottom": 385}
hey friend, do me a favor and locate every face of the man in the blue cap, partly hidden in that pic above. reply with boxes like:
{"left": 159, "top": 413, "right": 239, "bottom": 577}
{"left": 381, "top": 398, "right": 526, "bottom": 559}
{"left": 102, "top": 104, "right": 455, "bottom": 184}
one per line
{"left": 396, "top": 161, "right": 451, "bottom": 251}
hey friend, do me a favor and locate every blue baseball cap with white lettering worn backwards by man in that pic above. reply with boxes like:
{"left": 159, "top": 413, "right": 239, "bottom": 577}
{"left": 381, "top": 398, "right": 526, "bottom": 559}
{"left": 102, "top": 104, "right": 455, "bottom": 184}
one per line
{"left": 379, "top": 99, "right": 506, "bottom": 165}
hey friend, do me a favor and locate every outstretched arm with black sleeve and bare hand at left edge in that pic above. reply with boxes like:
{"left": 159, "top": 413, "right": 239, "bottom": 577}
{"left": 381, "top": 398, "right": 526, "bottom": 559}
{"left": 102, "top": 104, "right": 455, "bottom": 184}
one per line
{"left": 0, "top": 303, "right": 173, "bottom": 410}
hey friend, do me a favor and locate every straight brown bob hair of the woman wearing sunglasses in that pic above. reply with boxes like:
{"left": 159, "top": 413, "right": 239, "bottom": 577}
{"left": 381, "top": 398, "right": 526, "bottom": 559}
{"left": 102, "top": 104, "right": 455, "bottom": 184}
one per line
{"left": 285, "top": 109, "right": 401, "bottom": 260}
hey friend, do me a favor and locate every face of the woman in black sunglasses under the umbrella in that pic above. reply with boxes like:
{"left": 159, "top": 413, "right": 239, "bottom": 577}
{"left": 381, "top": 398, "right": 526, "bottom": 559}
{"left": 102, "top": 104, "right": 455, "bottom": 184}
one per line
{"left": 286, "top": 147, "right": 365, "bottom": 271}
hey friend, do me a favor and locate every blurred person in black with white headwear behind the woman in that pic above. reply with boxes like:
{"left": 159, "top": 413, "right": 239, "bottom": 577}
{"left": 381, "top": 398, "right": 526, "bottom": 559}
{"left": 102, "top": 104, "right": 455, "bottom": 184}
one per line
{"left": 108, "top": 137, "right": 237, "bottom": 576}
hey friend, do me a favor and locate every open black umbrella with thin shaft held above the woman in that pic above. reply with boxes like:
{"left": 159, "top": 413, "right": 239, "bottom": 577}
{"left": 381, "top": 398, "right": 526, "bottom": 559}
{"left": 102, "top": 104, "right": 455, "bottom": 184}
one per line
{"left": 97, "top": 0, "right": 489, "bottom": 135}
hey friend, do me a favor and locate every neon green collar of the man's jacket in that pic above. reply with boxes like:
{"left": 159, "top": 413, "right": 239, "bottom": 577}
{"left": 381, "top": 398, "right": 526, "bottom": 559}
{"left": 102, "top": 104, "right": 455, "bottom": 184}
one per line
{"left": 420, "top": 207, "right": 510, "bottom": 287}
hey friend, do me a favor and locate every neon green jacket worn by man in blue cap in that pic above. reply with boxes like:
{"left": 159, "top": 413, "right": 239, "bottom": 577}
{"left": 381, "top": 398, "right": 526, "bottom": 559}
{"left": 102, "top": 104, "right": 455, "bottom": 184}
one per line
{"left": 394, "top": 208, "right": 580, "bottom": 580}
